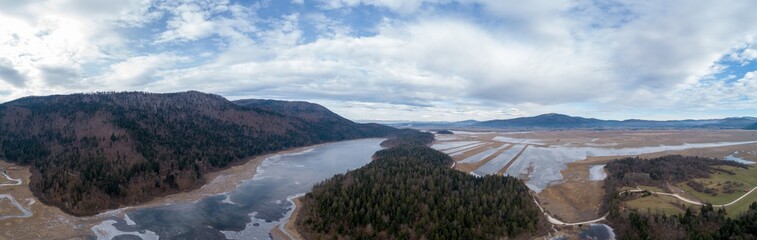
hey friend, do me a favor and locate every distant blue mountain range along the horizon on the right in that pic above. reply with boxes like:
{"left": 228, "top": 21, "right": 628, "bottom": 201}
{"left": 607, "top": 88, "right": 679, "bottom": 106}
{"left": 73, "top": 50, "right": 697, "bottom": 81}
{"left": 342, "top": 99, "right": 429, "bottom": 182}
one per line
{"left": 389, "top": 113, "right": 757, "bottom": 130}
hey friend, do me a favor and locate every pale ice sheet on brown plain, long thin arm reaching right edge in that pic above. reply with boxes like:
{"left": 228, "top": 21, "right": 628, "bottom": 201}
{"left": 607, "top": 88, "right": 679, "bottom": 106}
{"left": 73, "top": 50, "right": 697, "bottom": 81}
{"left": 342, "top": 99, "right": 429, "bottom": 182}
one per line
{"left": 506, "top": 141, "right": 757, "bottom": 192}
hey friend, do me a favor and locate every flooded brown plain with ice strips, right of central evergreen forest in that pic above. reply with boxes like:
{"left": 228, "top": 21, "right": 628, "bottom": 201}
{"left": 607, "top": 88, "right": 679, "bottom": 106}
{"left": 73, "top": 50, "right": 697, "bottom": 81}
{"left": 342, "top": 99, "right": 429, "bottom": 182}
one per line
{"left": 435, "top": 130, "right": 757, "bottom": 231}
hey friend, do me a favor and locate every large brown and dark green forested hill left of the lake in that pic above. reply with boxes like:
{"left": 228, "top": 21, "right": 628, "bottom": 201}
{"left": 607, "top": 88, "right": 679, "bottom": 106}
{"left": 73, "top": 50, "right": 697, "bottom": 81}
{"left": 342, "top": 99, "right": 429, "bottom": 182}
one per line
{"left": 0, "top": 92, "right": 398, "bottom": 215}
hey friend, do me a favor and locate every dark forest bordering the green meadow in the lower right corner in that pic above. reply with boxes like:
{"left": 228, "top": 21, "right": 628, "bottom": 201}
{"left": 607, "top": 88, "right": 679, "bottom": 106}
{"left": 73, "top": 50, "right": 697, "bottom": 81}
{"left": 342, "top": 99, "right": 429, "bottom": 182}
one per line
{"left": 605, "top": 155, "right": 757, "bottom": 239}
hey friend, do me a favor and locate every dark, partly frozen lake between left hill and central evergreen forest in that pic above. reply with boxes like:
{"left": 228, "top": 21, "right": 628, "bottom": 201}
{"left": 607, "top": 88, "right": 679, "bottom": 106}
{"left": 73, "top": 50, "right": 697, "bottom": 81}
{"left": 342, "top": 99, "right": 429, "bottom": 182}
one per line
{"left": 91, "top": 139, "right": 384, "bottom": 239}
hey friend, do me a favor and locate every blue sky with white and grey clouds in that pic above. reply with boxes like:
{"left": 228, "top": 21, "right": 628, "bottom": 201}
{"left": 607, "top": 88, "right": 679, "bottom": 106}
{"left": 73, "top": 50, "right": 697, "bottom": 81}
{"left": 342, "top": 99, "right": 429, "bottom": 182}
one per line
{"left": 0, "top": 0, "right": 757, "bottom": 121}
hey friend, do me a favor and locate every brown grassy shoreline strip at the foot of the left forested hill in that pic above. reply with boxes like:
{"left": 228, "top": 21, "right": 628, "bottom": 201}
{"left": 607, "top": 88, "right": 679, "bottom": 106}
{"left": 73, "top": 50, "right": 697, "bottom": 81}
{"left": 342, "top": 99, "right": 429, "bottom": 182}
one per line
{"left": 0, "top": 142, "right": 342, "bottom": 239}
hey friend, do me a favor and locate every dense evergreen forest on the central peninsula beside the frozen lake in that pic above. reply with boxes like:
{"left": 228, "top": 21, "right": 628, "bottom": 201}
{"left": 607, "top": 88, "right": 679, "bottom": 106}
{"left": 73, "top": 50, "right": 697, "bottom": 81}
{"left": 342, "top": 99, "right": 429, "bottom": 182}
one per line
{"left": 296, "top": 140, "right": 547, "bottom": 239}
